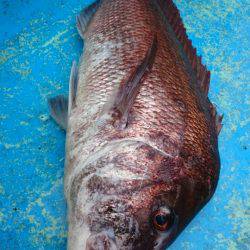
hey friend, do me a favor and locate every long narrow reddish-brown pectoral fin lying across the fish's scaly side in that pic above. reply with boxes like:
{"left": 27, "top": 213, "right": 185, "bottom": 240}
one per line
{"left": 112, "top": 35, "right": 157, "bottom": 129}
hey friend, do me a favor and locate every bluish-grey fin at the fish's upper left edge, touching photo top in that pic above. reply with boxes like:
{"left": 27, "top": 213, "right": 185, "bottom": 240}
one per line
{"left": 76, "top": 0, "right": 101, "bottom": 38}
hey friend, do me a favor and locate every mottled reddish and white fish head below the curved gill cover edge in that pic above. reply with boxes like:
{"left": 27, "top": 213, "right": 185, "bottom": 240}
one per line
{"left": 69, "top": 143, "right": 216, "bottom": 250}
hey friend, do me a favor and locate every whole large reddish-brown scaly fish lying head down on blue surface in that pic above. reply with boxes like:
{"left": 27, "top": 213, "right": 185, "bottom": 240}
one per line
{"left": 49, "top": 0, "right": 222, "bottom": 250}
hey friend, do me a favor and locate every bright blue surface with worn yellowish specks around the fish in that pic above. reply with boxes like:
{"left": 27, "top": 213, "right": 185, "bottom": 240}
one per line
{"left": 0, "top": 0, "right": 250, "bottom": 250}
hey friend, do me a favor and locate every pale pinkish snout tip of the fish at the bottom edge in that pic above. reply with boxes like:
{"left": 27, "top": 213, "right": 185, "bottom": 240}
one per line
{"left": 86, "top": 233, "right": 118, "bottom": 250}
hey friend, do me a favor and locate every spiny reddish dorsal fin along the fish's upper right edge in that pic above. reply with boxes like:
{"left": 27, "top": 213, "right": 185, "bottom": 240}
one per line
{"left": 157, "top": 0, "right": 210, "bottom": 95}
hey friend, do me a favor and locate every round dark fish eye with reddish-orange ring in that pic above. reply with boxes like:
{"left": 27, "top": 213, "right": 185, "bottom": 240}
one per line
{"left": 152, "top": 208, "right": 175, "bottom": 231}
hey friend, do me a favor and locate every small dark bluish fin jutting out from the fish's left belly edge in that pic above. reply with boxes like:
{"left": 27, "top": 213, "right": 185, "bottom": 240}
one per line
{"left": 48, "top": 95, "right": 68, "bottom": 130}
